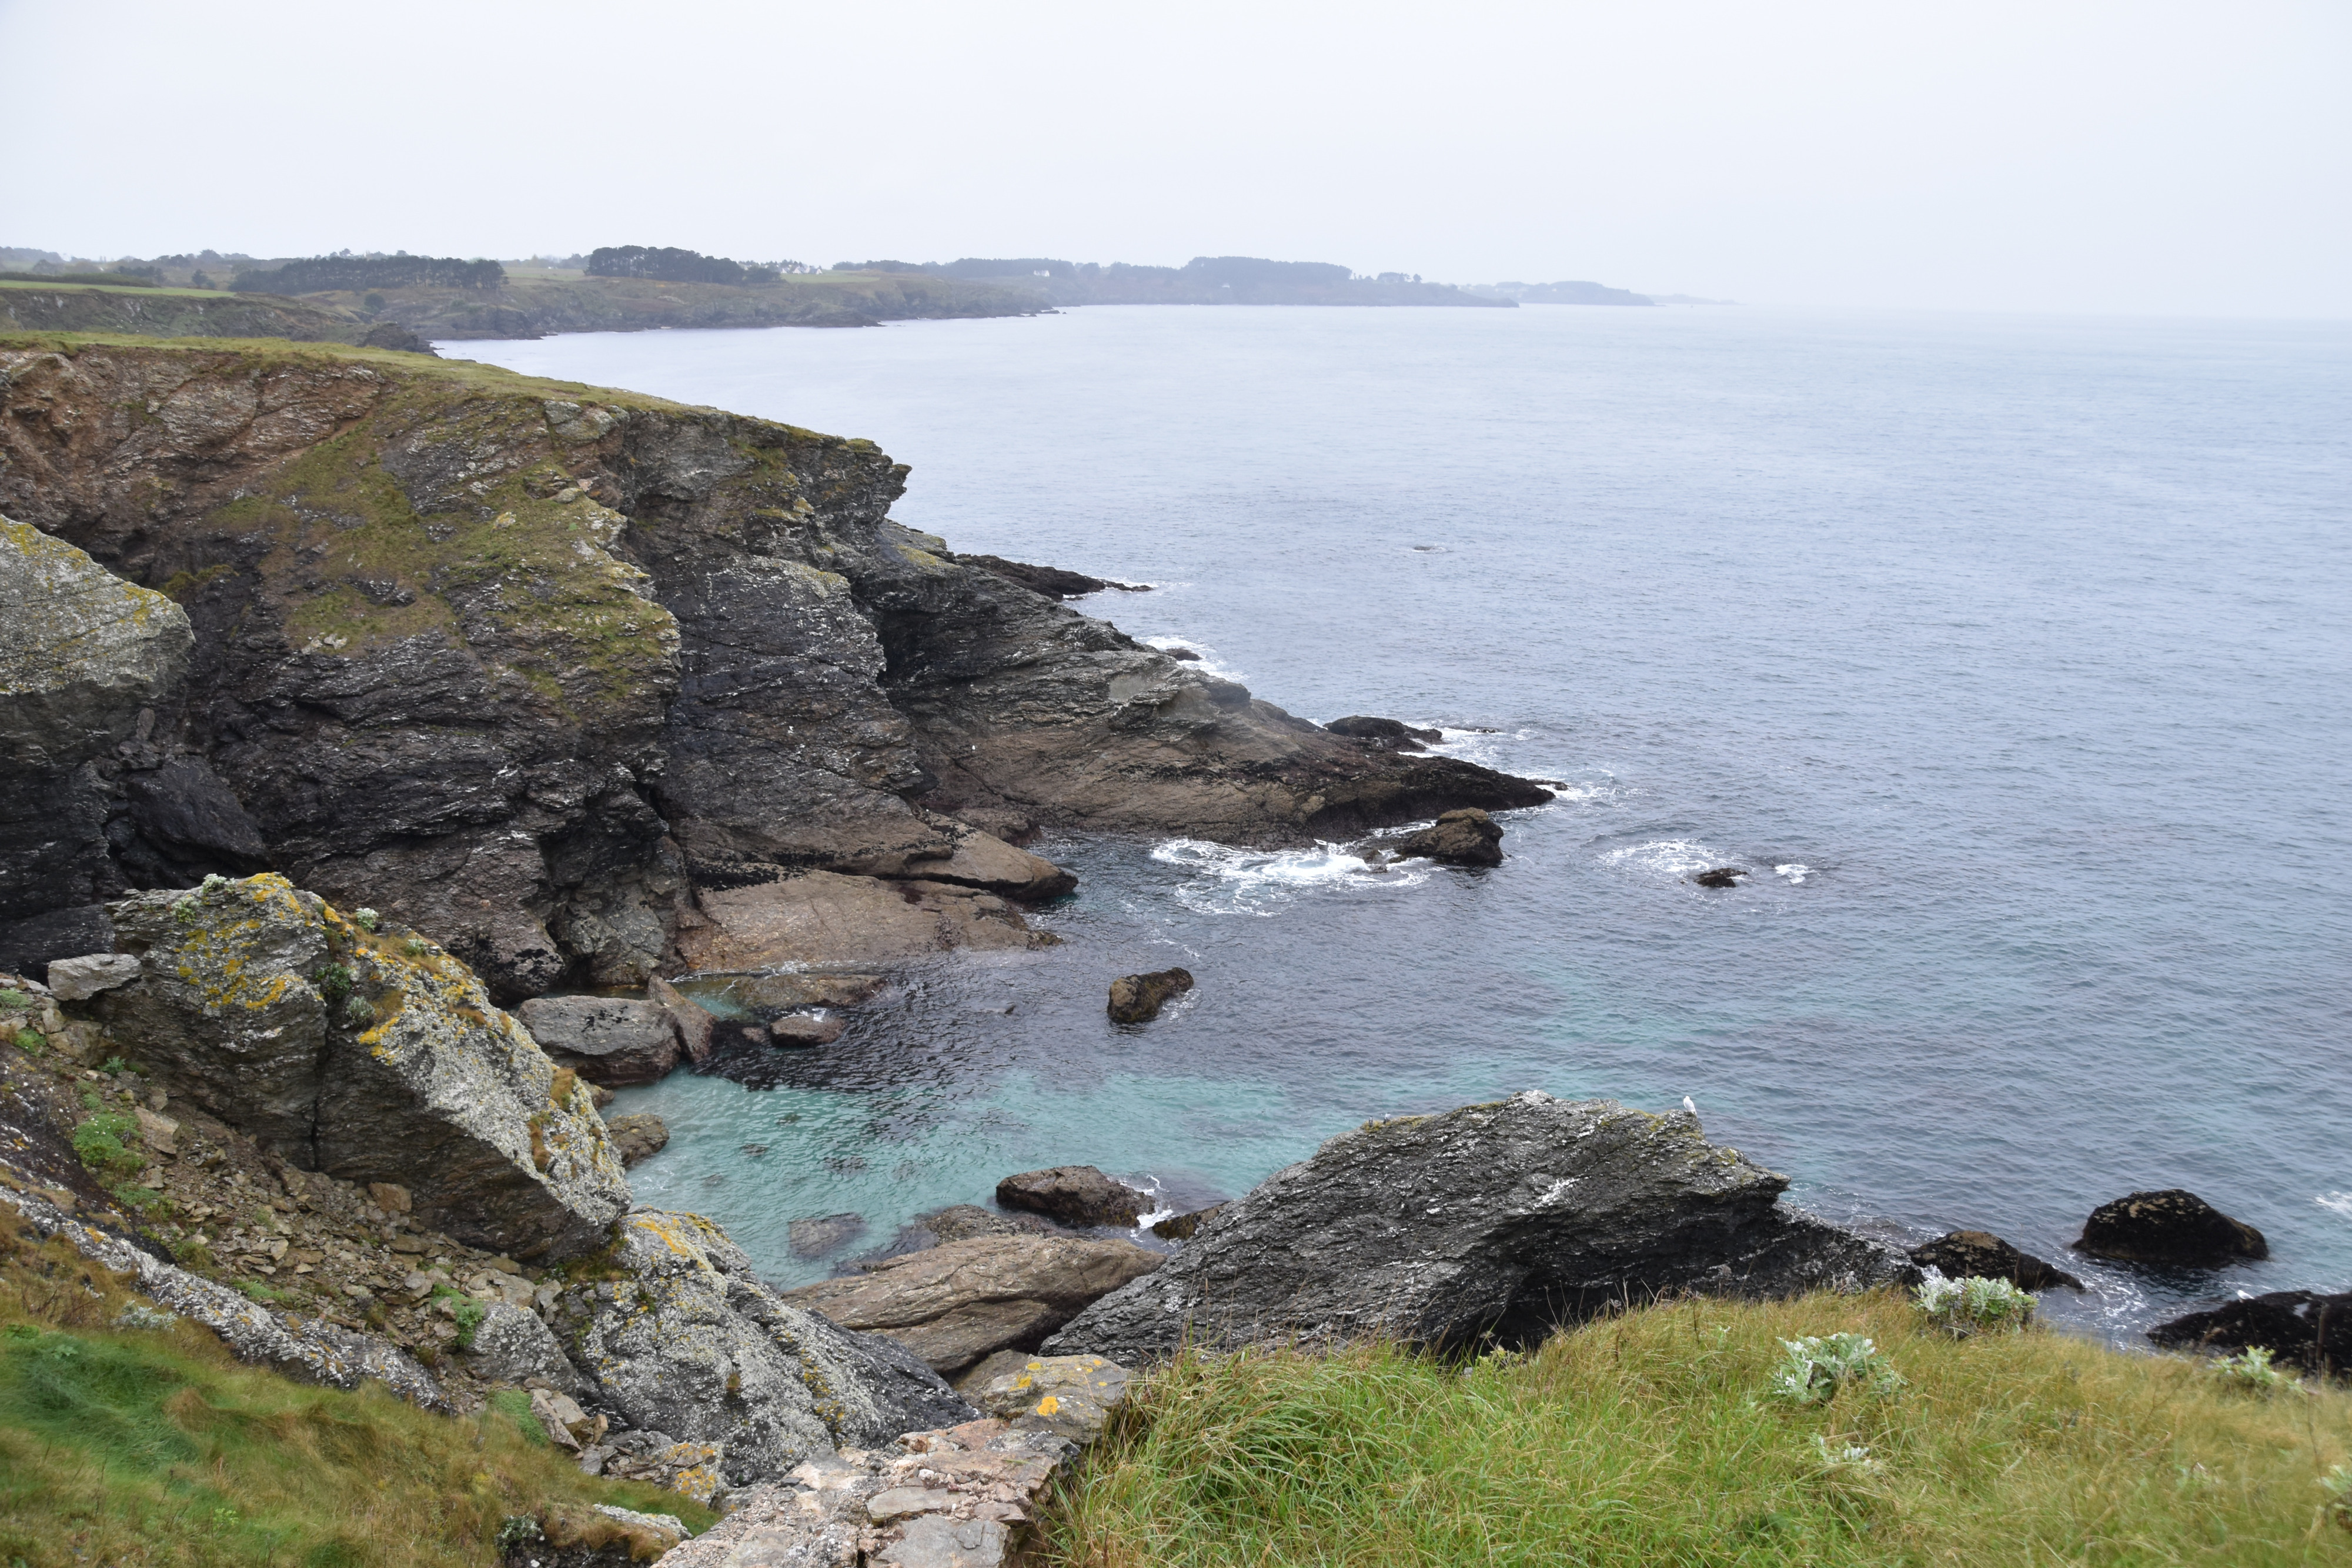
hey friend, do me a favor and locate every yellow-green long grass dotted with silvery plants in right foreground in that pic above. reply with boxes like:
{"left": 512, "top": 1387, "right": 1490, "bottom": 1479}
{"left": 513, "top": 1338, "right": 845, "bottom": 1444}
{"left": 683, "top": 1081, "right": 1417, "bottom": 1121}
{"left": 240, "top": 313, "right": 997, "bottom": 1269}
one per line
{"left": 1047, "top": 1295, "right": 2352, "bottom": 1568}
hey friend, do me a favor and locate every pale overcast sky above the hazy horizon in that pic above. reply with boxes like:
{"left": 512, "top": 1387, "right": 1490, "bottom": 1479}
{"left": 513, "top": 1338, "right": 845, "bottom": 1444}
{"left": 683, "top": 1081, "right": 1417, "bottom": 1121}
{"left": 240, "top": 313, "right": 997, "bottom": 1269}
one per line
{"left": 0, "top": 0, "right": 2352, "bottom": 317}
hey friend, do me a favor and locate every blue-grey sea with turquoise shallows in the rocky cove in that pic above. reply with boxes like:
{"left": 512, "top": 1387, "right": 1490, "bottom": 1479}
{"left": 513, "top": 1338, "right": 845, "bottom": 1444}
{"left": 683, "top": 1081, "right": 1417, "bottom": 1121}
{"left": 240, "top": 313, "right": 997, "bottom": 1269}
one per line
{"left": 449, "top": 308, "right": 2352, "bottom": 1333}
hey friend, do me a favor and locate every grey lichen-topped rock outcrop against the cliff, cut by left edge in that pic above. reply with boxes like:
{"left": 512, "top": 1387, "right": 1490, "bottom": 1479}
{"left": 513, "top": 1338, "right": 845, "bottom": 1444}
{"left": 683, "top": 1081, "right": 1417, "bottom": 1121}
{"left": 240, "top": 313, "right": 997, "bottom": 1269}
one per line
{"left": 0, "top": 517, "right": 195, "bottom": 973}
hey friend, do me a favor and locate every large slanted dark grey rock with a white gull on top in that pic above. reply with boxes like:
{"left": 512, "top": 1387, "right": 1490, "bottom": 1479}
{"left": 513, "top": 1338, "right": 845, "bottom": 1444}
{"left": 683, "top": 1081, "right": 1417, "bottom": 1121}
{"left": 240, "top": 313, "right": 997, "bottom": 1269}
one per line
{"left": 1042, "top": 1091, "right": 1919, "bottom": 1366}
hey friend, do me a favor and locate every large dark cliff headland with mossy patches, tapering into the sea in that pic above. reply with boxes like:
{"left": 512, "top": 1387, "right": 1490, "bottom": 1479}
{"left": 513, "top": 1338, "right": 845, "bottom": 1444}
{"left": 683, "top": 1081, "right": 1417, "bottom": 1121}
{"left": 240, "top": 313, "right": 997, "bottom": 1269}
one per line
{"left": 0, "top": 339, "right": 1545, "bottom": 999}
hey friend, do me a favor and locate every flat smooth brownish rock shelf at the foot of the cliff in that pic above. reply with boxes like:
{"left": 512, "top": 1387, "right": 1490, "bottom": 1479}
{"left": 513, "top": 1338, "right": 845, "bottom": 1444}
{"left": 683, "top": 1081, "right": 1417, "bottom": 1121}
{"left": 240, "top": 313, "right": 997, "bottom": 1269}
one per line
{"left": 677, "top": 872, "right": 1037, "bottom": 968}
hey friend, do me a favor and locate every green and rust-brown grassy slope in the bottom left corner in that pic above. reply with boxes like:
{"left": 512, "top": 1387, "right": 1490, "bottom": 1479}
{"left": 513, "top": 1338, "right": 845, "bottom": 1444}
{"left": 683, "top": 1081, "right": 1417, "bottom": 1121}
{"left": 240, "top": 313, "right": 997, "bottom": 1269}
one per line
{"left": 0, "top": 1227, "right": 713, "bottom": 1568}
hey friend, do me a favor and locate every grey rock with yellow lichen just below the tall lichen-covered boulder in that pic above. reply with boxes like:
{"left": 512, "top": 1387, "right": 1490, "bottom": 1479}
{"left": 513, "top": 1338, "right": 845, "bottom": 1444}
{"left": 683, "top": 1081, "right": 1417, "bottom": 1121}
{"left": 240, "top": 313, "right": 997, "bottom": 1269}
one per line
{"left": 557, "top": 1208, "right": 976, "bottom": 1486}
